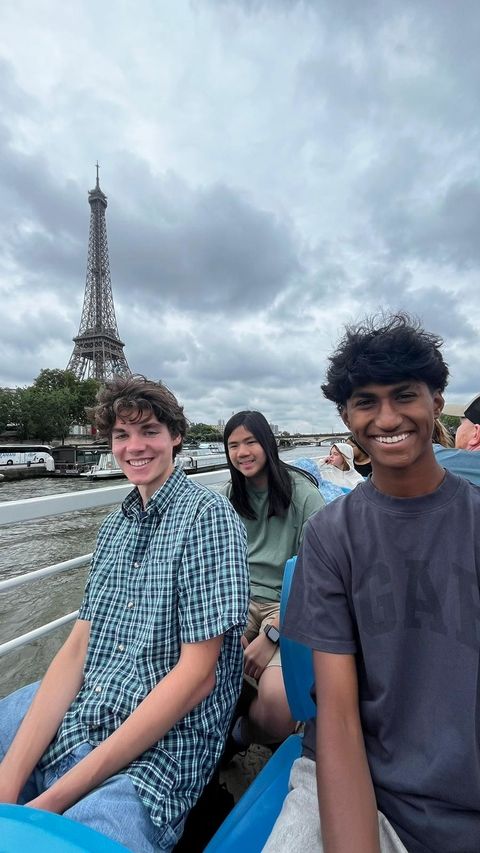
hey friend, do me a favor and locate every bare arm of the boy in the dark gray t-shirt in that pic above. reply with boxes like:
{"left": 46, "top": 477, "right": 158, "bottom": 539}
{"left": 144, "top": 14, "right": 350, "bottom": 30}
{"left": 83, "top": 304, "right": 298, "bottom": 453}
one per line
{"left": 313, "top": 651, "right": 380, "bottom": 853}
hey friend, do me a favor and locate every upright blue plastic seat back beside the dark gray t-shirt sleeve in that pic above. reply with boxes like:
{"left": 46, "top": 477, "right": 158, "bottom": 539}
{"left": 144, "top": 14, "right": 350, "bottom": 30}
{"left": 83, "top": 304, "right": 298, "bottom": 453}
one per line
{"left": 280, "top": 557, "right": 317, "bottom": 720}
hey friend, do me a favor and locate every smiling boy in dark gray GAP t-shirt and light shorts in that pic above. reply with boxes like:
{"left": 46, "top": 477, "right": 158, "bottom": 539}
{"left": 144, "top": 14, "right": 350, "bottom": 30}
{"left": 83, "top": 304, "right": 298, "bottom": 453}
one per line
{"left": 265, "top": 315, "right": 480, "bottom": 853}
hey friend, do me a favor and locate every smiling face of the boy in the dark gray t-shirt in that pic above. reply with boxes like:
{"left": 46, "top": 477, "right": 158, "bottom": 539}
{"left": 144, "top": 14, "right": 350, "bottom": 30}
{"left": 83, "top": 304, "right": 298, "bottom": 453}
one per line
{"left": 343, "top": 380, "right": 443, "bottom": 497}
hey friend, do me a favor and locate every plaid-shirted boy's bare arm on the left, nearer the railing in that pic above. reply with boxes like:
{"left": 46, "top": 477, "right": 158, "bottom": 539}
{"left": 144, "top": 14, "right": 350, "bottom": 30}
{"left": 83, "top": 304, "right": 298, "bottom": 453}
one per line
{"left": 0, "top": 620, "right": 90, "bottom": 803}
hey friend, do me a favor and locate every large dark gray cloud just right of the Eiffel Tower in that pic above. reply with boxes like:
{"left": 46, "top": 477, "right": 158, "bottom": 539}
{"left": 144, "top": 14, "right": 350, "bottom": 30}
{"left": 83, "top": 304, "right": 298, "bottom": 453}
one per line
{"left": 110, "top": 176, "right": 301, "bottom": 314}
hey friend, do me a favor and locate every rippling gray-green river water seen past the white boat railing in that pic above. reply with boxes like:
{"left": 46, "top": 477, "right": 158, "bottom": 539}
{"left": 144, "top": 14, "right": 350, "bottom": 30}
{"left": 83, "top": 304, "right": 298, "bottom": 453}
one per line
{"left": 0, "top": 447, "right": 327, "bottom": 697}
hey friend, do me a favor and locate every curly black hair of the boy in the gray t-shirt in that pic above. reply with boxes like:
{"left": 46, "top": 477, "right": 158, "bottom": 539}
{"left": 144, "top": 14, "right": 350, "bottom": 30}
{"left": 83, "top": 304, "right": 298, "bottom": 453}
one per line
{"left": 321, "top": 312, "right": 448, "bottom": 412}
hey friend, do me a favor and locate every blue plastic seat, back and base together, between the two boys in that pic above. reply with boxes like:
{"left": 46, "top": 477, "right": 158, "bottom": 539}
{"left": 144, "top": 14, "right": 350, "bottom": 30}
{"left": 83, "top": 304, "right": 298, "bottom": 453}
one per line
{"left": 204, "top": 557, "right": 316, "bottom": 853}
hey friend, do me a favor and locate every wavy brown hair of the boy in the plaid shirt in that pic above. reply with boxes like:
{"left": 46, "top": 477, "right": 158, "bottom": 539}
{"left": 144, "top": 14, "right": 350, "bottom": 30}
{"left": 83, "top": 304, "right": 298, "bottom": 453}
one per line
{"left": 88, "top": 374, "right": 188, "bottom": 456}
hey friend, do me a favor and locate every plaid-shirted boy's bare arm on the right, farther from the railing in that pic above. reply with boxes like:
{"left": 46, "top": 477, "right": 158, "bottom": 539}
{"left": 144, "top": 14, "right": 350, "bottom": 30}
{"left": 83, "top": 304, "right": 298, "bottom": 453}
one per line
{"left": 28, "top": 635, "right": 223, "bottom": 814}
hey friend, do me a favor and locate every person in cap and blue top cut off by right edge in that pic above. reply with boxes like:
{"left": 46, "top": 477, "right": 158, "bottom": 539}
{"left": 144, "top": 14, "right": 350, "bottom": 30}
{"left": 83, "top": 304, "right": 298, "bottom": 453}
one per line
{"left": 433, "top": 394, "right": 480, "bottom": 486}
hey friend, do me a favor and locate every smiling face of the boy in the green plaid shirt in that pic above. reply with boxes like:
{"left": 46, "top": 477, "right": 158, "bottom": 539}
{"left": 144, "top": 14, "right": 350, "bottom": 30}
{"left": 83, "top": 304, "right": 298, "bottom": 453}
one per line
{"left": 112, "top": 413, "right": 181, "bottom": 506}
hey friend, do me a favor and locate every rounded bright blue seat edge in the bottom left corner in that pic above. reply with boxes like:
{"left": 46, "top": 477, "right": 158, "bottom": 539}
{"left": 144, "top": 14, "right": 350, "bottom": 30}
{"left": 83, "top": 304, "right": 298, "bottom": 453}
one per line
{"left": 0, "top": 804, "right": 128, "bottom": 853}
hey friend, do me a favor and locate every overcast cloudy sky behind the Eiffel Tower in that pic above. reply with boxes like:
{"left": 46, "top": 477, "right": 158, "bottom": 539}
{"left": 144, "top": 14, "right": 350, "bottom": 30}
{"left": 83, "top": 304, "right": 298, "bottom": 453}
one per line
{"left": 0, "top": 0, "right": 480, "bottom": 430}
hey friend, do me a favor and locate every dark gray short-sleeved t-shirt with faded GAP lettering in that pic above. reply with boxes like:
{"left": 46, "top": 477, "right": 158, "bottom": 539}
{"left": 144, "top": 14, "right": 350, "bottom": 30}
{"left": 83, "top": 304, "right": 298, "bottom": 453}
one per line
{"left": 284, "top": 471, "right": 480, "bottom": 853}
